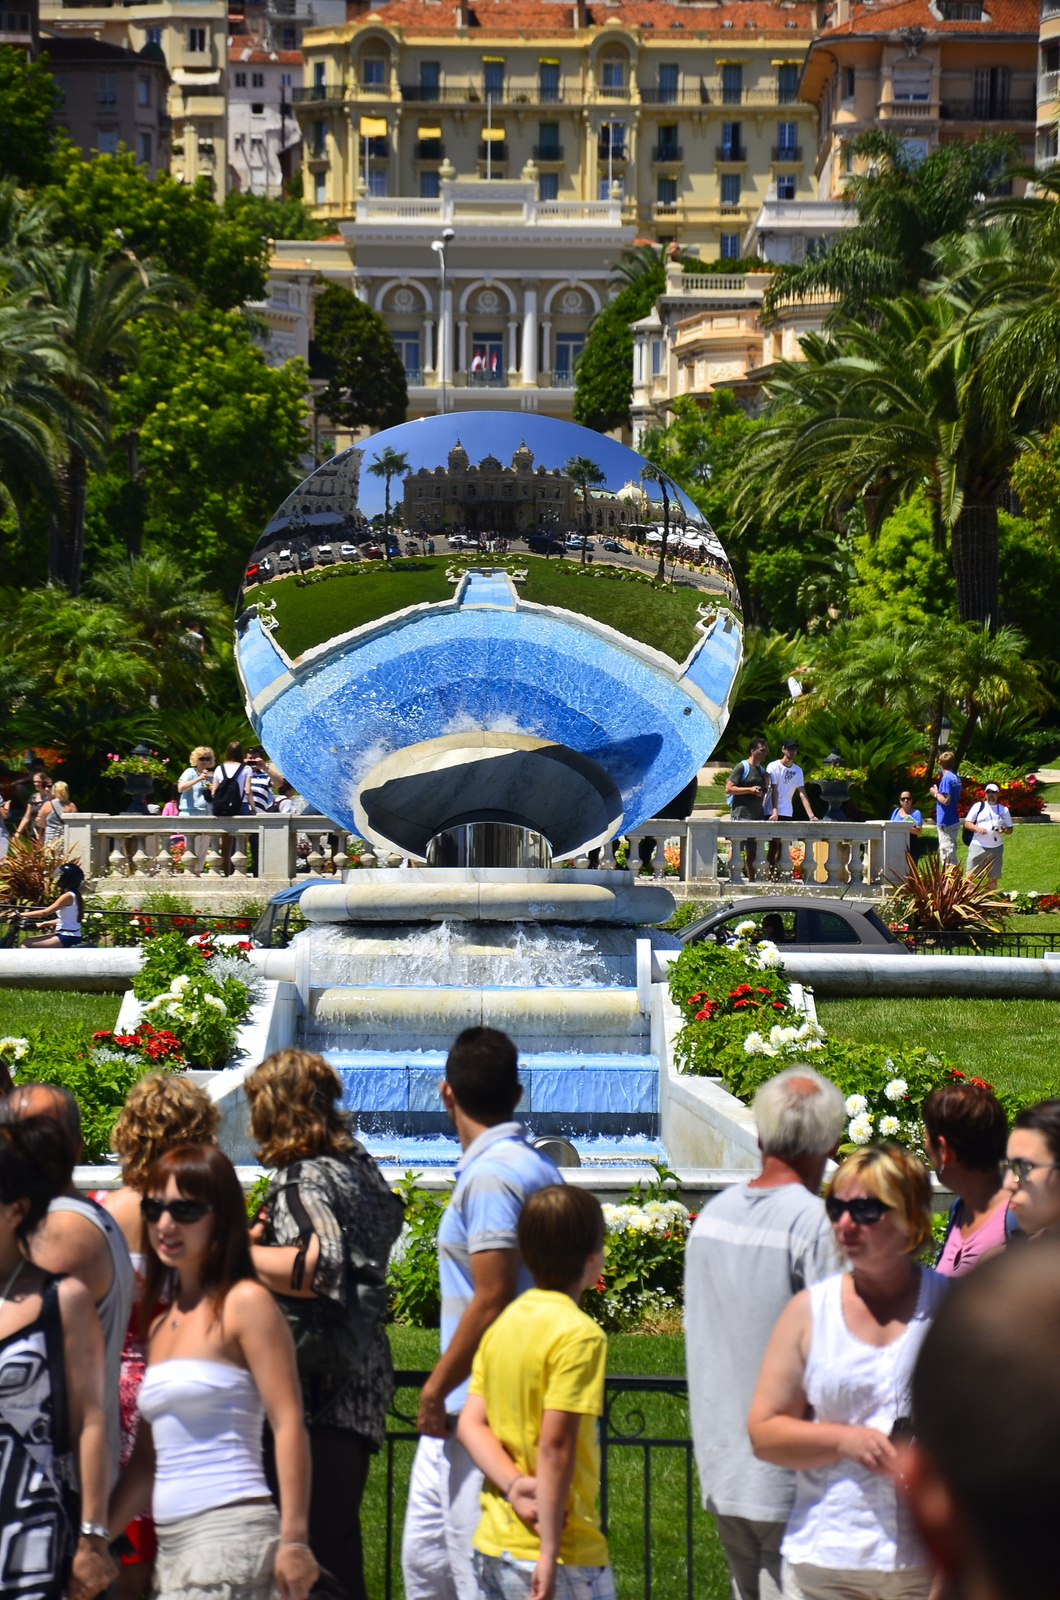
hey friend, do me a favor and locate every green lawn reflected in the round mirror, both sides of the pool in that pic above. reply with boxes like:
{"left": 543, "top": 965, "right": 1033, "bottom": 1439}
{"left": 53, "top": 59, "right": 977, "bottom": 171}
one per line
{"left": 247, "top": 555, "right": 705, "bottom": 661}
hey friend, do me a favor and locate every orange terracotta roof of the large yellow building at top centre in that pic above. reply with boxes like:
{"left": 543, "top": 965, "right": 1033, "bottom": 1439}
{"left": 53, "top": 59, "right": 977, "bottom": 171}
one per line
{"left": 352, "top": 0, "right": 816, "bottom": 37}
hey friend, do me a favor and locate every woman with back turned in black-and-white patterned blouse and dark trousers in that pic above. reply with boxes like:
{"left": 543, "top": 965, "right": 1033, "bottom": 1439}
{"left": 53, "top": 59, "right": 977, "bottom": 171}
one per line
{"left": 243, "top": 1050, "right": 404, "bottom": 1600}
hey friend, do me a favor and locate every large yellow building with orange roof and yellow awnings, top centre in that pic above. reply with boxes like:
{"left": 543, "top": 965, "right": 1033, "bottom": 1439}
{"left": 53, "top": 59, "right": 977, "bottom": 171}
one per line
{"left": 295, "top": 0, "right": 817, "bottom": 261}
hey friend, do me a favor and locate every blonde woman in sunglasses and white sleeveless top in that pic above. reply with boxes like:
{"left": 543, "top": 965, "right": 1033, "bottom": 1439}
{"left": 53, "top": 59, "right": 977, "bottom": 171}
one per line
{"left": 748, "top": 1146, "right": 946, "bottom": 1600}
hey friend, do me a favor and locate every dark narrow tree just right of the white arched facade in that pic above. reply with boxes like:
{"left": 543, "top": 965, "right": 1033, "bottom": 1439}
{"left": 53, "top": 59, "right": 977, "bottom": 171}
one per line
{"left": 573, "top": 246, "right": 666, "bottom": 434}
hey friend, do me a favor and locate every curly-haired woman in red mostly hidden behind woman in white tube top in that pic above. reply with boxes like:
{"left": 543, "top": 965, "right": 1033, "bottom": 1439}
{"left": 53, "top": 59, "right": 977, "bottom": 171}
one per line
{"left": 96, "top": 1072, "right": 221, "bottom": 1600}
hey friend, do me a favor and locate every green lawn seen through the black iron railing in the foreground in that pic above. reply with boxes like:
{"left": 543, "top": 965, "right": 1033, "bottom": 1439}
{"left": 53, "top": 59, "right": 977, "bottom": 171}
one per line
{"left": 371, "top": 1326, "right": 729, "bottom": 1600}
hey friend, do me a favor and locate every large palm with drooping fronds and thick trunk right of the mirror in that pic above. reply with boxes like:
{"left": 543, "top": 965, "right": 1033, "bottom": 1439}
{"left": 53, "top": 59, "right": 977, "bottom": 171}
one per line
{"left": 737, "top": 288, "right": 1026, "bottom": 627}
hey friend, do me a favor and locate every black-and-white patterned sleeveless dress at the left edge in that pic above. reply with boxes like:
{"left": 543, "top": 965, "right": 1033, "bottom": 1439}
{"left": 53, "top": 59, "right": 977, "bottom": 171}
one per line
{"left": 0, "top": 1275, "right": 75, "bottom": 1600}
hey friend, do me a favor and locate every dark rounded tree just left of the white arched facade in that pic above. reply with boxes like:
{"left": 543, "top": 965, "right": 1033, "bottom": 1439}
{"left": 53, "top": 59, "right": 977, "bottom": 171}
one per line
{"left": 311, "top": 283, "right": 408, "bottom": 429}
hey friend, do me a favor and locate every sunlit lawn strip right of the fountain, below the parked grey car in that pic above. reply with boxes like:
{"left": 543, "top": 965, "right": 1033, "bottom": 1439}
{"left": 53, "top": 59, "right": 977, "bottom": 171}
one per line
{"left": 817, "top": 992, "right": 1060, "bottom": 1098}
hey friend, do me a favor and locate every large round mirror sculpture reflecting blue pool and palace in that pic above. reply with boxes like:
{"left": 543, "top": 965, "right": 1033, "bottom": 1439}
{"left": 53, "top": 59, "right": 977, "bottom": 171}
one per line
{"left": 237, "top": 411, "right": 741, "bottom": 864}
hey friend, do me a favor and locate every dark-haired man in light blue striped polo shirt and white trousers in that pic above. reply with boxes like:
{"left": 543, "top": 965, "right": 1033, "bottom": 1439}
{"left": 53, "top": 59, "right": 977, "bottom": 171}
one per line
{"left": 402, "top": 1027, "right": 562, "bottom": 1600}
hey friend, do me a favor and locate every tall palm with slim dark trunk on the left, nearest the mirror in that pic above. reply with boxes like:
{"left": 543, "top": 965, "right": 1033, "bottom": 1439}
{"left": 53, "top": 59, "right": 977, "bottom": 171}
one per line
{"left": 40, "top": 250, "right": 178, "bottom": 595}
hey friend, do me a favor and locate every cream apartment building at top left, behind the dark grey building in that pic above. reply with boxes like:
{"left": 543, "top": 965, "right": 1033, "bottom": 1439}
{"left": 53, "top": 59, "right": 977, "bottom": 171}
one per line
{"left": 40, "top": 0, "right": 229, "bottom": 200}
